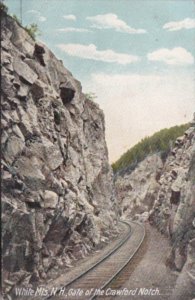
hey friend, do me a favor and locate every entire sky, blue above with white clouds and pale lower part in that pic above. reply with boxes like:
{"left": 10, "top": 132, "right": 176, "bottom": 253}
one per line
{"left": 5, "top": 0, "right": 195, "bottom": 162}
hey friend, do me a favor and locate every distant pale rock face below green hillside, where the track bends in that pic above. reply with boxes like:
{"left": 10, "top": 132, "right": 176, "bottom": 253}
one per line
{"left": 115, "top": 154, "right": 163, "bottom": 219}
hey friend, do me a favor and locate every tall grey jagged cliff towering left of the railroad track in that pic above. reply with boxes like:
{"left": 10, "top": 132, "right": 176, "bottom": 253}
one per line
{"left": 1, "top": 16, "right": 118, "bottom": 288}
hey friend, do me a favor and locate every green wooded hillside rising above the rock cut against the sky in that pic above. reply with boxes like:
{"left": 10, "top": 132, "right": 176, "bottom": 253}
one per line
{"left": 112, "top": 124, "right": 189, "bottom": 172}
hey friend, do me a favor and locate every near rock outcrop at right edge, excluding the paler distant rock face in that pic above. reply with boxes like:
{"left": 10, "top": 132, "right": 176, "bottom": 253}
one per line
{"left": 149, "top": 119, "right": 195, "bottom": 300}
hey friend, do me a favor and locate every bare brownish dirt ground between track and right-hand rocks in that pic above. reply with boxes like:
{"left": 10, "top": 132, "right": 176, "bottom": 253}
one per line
{"left": 109, "top": 224, "right": 179, "bottom": 300}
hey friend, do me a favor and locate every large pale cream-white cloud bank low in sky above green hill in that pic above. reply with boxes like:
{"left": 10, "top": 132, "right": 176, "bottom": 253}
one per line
{"left": 82, "top": 72, "right": 195, "bottom": 162}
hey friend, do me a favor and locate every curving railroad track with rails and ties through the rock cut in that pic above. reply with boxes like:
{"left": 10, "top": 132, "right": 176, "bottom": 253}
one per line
{"left": 44, "top": 222, "right": 145, "bottom": 300}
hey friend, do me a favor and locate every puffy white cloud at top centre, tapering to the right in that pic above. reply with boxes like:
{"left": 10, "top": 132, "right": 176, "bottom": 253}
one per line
{"left": 86, "top": 13, "right": 146, "bottom": 34}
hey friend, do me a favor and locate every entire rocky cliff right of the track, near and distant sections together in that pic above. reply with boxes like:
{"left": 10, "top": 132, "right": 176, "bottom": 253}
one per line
{"left": 116, "top": 119, "right": 195, "bottom": 300}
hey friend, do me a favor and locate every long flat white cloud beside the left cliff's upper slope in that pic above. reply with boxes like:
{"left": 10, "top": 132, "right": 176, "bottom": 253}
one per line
{"left": 57, "top": 44, "right": 140, "bottom": 65}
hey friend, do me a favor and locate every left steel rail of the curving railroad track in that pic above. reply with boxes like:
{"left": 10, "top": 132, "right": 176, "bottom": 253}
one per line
{"left": 43, "top": 221, "right": 131, "bottom": 300}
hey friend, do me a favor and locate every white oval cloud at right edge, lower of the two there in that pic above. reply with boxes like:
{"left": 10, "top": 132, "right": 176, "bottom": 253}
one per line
{"left": 147, "top": 47, "right": 194, "bottom": 66}
